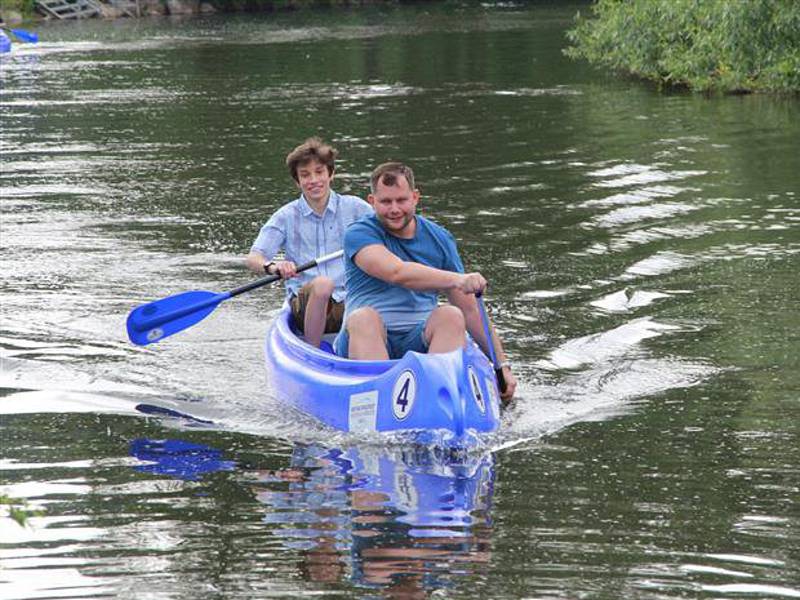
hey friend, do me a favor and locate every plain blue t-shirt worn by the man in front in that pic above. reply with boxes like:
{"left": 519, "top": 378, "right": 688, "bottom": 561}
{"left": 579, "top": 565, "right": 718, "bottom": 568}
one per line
{"left": 344, "top": 215, "right": 464, "bottom": 331}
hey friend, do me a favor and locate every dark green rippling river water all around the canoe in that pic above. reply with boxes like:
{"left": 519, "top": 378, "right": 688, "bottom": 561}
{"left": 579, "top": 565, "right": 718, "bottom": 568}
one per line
{"left": 0, "top": 4, "right": 800, "bottom": 598}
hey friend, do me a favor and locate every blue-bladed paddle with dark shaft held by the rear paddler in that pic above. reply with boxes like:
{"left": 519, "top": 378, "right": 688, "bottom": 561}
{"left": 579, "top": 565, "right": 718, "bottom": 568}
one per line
{"left": 127, "top": 250, "right": 342, "bottom": 346}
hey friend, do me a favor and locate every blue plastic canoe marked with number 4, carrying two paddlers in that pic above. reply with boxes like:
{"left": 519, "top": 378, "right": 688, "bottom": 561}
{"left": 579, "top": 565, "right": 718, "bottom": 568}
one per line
{"left": 265, "top": 309, "right": 500, "bottom": 440}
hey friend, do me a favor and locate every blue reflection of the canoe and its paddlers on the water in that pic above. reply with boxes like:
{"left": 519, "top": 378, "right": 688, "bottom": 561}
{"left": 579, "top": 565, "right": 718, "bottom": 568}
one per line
{"left": 256, "top": 446, "right": 494, "bottom": 598}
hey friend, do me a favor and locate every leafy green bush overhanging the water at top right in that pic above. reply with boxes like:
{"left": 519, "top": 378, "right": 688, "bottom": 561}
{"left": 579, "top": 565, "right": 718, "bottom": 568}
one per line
{"left": 565, "top": 0, "right": 800, "bottom": 92}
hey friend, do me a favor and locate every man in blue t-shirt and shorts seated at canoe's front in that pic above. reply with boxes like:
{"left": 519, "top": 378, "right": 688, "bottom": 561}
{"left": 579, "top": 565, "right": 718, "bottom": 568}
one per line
{"left": 334, "top": 162, "right": 517, "bottom": 400}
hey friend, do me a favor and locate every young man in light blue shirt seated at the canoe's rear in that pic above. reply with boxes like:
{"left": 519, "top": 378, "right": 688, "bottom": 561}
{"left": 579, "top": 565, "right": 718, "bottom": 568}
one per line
{"left": 246, "top": 138, "right": 372, "bottom": 347}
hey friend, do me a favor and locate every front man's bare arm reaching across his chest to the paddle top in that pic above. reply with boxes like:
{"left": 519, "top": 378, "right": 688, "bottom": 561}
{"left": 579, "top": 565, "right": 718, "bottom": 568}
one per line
{"left": 353, "top": 244, "right": 486, "bottom": 294}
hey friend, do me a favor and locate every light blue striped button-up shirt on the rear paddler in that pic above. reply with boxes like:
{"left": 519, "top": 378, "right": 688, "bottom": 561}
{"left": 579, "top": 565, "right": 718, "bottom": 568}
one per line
{"left": 250, "top": 190, "right": 373, "bottom": 302}
